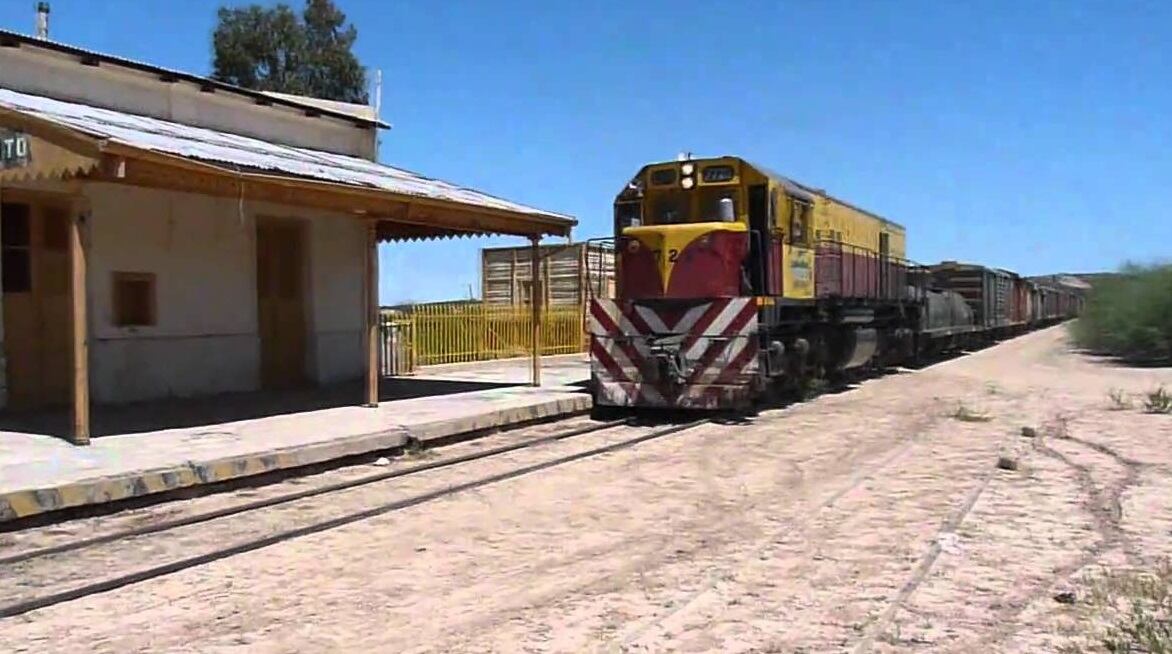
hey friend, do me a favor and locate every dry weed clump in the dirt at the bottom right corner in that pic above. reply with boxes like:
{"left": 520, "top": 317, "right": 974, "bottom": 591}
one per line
{"left": 1064, "top": 560, "right": 1172, "bottom": 654}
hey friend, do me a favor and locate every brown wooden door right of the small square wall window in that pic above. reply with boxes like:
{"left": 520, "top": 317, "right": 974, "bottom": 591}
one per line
{"left": 257, "top": 218, "right": 307, "bottom": 389}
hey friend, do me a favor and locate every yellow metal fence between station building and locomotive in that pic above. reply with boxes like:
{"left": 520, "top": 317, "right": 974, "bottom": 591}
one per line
{"left": 382, "top": 302, "right": 585, "bottom": 375}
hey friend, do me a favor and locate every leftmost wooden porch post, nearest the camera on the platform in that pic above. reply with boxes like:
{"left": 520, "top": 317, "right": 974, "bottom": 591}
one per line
{"left": 69, "top": 198, "right": 89, "bottom": 445}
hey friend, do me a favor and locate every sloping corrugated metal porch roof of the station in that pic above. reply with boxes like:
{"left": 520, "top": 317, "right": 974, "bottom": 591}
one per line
{"left": 0, "top": 89, "right": 573, "bottom": 224}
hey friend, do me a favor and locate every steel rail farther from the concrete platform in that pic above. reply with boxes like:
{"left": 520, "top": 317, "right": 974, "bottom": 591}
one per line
{"left": 0, "top": 418, "right": 710, "bottom": 619}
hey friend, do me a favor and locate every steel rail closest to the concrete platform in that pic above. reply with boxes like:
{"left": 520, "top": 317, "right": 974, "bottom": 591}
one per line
{"left": 0, "top": 420, "right": 627, "bottom": 566}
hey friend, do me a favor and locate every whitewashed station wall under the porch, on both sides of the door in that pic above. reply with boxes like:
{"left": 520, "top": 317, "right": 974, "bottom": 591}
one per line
{"left": 0, "top": 183, "right": 366, "bottom": 403}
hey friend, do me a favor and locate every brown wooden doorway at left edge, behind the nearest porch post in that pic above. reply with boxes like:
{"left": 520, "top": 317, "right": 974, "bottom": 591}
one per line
{"left": 0, "top": 191, "right": 73, "bottom": 409}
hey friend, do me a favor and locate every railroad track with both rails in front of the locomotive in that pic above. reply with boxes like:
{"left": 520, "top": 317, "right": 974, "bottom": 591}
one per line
{"left": 0, "top": 420, "right": 709, "bottom": 619}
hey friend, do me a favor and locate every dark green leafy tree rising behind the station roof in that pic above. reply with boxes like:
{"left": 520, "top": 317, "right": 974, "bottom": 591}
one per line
{"left": 212, "top": 0, "right": 367, "bottom": 103}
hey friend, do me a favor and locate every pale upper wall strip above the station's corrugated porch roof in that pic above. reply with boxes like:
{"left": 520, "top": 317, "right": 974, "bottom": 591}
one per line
{"left": 0, "top": 46, "right": 377, "bottom": 161}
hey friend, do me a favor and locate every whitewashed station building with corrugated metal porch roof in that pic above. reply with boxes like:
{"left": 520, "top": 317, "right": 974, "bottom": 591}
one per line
{"left": 0, "top": 26, "right": 574, "bottom": 443}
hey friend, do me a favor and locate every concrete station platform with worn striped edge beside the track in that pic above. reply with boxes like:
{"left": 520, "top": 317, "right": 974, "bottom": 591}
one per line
{"left": 0, "top": 355, "right": 591, "bottom": 523}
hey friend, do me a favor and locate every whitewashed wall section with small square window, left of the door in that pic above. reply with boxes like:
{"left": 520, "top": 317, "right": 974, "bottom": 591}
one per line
{"left": 87, "top": 184, "right": 260, "bottom": 402}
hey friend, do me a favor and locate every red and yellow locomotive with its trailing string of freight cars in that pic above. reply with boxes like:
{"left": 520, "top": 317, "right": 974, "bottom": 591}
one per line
{"left": 587, "top": 156, "right": 1082, "bottom": 409}
